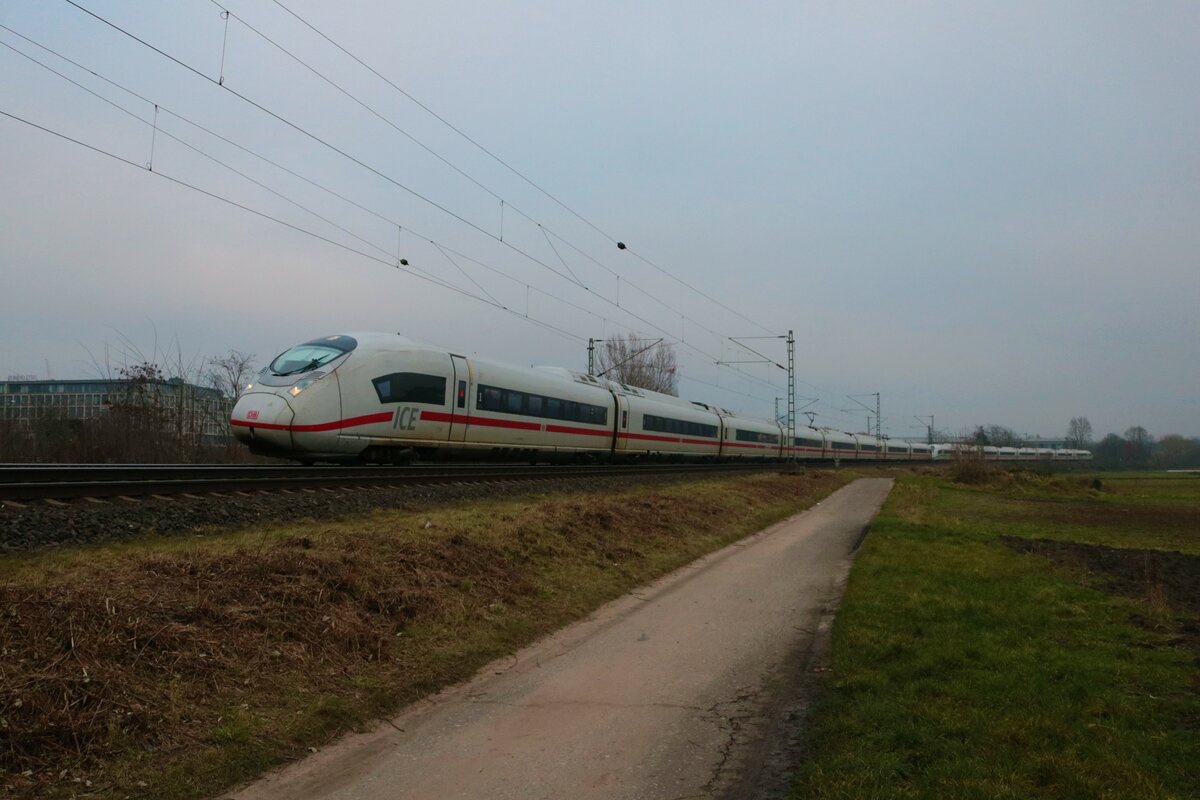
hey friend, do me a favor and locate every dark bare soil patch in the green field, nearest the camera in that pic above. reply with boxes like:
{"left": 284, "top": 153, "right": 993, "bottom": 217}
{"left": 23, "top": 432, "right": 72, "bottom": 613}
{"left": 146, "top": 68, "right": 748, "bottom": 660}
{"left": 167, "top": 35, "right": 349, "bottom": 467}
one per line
{"left": 1001, "top": 536, "right": 1200, "bottom": 663}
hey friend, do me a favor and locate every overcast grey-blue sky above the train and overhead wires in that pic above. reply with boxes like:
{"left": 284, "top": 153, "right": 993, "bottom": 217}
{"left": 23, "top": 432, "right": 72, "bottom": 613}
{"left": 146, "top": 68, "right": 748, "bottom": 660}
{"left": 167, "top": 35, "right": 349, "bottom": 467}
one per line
{"left": 0, "top": 0, "right": 1200, "bottom": 435}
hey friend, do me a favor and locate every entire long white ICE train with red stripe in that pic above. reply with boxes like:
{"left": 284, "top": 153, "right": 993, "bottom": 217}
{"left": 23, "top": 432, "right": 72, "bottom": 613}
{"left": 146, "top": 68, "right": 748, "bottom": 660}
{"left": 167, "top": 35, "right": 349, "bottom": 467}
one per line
{"left": 230, "top": 333, "right": 1091, "bottom": 463}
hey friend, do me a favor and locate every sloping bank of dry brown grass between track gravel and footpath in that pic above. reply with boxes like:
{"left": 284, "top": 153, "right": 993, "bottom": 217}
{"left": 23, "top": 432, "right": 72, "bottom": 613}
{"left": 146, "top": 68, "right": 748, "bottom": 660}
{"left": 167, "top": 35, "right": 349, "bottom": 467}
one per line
{"left": 0, "top": 471, "right": 853, "bottom": 800}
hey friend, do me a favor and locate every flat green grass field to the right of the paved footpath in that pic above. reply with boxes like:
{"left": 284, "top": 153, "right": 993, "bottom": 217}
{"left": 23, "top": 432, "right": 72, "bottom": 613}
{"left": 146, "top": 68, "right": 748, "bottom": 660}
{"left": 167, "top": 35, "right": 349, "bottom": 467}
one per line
{"left": 793, "top": 473, "right": 1200, "bottom": 800}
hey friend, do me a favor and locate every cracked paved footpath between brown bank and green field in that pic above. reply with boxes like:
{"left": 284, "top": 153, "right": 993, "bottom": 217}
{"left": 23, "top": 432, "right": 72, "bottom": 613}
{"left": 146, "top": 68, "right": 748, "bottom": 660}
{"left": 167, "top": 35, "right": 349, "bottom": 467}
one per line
{"left": 228, "top": 479, "right": 892, "bottom": 800}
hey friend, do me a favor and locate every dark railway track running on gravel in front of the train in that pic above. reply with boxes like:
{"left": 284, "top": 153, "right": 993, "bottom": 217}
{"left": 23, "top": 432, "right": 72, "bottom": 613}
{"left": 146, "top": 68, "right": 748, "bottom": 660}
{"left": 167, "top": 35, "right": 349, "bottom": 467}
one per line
{"left": 0, "top": 463, "right": 780, "bottom": 501}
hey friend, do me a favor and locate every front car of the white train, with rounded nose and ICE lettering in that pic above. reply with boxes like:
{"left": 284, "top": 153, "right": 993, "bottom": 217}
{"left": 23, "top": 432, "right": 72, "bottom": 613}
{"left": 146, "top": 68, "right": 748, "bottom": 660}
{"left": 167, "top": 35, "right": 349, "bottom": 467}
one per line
{"left": 230, "top": 333, "right": 617, "bottom": 462}
